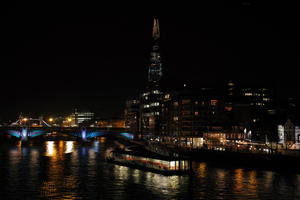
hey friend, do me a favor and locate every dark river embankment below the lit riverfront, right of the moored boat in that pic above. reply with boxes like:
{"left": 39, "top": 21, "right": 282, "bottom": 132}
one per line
{"left": 134, "top": 143, "right": 300, "bottom": 172}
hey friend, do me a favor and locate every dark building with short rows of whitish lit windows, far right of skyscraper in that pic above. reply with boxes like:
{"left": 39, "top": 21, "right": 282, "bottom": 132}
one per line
{"left": 225, "top": 81, "right": 276, "bottom": 140}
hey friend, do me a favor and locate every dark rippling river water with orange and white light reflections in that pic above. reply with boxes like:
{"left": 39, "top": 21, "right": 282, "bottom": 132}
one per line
{"left": 0, "top": 141, "right": 300, "bottom": 200}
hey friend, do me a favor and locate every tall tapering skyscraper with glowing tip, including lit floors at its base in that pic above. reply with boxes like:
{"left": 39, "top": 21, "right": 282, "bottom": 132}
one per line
{"left": 140, "top": 18, "right": 162, "bottom": 138}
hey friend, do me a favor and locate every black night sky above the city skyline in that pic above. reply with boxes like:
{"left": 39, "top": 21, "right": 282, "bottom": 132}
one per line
{"left": 0, "top": 1, "right": 300, "bottom": 118}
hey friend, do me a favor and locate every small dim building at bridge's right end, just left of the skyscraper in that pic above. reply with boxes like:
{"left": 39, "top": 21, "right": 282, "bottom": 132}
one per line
{"left": 124, "top": 99, "right": 140, "bottom": 134}
